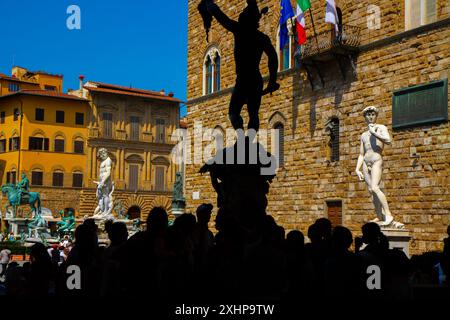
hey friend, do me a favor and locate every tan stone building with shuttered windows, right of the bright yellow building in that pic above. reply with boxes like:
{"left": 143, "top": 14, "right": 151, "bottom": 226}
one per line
{"left": 72, "top": 81, "right": 180, "bottom": 221}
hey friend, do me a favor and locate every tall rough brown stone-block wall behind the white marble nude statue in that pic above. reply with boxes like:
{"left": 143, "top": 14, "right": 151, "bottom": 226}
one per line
{"left": 186, "top": 0, "right": 450, "bottom": 254}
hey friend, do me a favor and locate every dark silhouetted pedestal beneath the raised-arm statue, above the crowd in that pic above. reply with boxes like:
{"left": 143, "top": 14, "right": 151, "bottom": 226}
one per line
{"left": 200, "top": 138, "right": 277, "bottom": 229}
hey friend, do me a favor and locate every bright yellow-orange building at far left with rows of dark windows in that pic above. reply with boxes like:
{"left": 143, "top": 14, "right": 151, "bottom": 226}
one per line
{"left": 0, "top": 70, "right": 89, "bottom": 213}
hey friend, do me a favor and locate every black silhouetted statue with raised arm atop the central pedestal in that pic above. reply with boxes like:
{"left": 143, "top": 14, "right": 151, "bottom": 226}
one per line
{"left": 200, "top": 0, "right": 280, "bottom": 131}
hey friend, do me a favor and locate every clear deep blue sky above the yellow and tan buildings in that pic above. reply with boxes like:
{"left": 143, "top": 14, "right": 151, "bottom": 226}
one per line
{"left": 0, "top": 0, "right": 187, "bottom": 114}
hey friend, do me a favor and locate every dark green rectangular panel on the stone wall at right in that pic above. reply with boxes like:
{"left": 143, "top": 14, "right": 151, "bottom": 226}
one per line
{"left": 392, "top": 79, "right": 448, "bottom": 129}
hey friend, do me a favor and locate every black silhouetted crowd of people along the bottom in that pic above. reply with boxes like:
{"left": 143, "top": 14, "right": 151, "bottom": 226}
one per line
{"left": 0, "top": 204, "right": 450, "bottom": 302}
